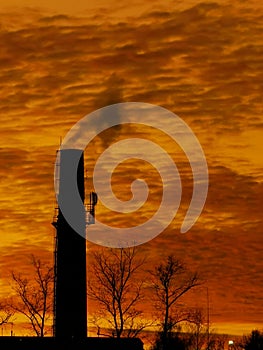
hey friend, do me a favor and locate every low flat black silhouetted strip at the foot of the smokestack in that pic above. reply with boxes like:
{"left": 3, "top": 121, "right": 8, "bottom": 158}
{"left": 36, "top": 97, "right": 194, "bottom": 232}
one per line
{"left": 0, "top": 337, "right": 143, "bottom": 350}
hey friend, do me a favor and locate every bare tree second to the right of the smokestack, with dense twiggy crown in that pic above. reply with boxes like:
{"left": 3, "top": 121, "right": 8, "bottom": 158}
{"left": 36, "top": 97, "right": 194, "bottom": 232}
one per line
{"left": 151, "top": 255, "right": 200, "bottom": 348}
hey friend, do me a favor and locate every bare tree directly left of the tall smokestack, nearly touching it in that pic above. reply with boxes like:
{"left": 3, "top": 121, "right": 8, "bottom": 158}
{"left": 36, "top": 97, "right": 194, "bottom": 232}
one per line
{"left": 11, "top": 256, "right": 54, "bottom": 337}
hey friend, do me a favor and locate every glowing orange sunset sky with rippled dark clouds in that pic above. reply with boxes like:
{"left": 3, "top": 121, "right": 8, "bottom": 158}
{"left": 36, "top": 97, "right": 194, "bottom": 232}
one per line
{"left": 0, "top": 0, "right": 263, "bottom": 334}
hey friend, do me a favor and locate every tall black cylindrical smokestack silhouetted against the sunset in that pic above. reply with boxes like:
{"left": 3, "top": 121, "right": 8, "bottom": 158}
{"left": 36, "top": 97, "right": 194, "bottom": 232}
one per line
{"left": 53, "top": 149, "right": 87, "bottom": 339}
